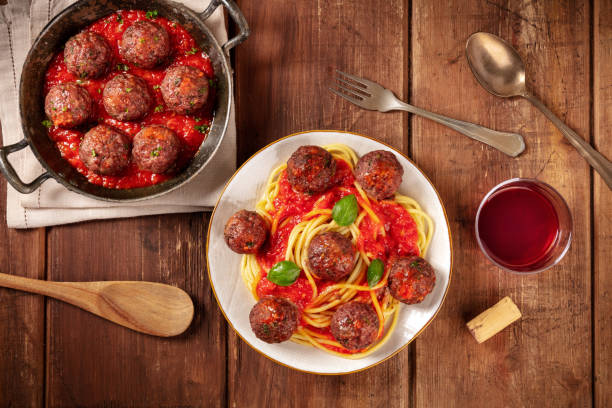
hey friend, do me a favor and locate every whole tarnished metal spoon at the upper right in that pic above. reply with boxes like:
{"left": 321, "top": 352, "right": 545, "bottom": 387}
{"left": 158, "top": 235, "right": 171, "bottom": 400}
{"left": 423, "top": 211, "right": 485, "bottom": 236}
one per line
{"left": 465, "top": 33, "right": 612, "bottom": 190}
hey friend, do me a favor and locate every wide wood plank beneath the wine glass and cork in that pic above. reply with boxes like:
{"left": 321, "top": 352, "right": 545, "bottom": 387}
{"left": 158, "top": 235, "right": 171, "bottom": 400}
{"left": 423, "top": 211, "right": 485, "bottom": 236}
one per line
{"left": 411, "top": 0, "right": 592, "bottom": 407}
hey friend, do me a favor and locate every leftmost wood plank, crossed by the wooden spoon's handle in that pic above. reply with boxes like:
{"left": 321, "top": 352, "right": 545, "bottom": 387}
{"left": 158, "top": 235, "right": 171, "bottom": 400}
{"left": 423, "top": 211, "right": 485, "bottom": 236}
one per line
{"left": 0, "top": 132, "right": 45, "bottom": 407}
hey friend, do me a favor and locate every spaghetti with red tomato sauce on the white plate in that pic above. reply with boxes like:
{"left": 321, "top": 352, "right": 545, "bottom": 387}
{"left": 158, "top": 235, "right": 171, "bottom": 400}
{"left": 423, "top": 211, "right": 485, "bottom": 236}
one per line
{"left": 241, "top": 144, "right": 433, "bottom": 359}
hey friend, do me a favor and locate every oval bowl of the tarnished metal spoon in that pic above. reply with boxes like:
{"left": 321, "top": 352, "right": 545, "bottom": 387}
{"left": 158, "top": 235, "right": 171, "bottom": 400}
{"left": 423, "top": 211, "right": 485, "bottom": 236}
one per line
{"left": 465, "top": 33, "right": 527, "bottom": 98}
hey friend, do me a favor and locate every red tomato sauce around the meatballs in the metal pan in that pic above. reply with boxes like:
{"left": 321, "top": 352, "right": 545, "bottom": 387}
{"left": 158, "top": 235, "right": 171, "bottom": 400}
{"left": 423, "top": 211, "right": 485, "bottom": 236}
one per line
{"left": 44, "top": 10, "right": 215, "bottom": 189}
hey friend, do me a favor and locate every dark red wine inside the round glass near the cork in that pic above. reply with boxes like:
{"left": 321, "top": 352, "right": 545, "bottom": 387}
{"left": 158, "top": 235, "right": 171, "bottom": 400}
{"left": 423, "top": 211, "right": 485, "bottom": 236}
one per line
{"left": 478, "top": 184, "right": 559, "bottom": 271}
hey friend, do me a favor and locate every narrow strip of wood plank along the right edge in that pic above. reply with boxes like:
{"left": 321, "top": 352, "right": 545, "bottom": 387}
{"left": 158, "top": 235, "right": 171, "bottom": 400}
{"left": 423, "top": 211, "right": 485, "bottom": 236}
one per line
{"left": 593, "top": 0, "right": 612, "bottom": 407}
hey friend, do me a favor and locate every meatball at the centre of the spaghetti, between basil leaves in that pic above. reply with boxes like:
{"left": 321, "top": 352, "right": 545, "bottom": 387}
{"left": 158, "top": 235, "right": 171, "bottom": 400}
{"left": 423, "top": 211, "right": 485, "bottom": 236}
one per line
{"left": 308, "top": 232, "right": 355, "bottom": 281}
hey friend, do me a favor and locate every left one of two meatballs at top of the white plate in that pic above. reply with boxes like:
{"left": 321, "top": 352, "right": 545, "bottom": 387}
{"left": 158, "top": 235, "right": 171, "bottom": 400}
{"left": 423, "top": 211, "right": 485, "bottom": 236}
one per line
{"left": 287, "top": 146, "right": 336, "bottom": 194}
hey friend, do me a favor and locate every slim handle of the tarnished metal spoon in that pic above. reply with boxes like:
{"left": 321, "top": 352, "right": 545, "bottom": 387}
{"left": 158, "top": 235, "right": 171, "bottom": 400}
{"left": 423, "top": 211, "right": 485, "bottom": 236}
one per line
{"left": 523, "top": 93, "right": 612, "bottom": 190}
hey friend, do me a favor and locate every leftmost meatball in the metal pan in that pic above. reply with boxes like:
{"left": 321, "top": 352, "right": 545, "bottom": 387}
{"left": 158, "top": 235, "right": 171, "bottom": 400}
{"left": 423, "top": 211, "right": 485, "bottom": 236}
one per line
{"left": 45, "top": 82, "right": 93, "bottom": 128}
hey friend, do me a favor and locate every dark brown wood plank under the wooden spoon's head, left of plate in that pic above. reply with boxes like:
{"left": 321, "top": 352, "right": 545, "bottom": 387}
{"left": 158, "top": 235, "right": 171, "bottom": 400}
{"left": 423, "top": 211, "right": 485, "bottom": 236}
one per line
{"left": 47, "top": 213, "right": 226, "bottom": 407}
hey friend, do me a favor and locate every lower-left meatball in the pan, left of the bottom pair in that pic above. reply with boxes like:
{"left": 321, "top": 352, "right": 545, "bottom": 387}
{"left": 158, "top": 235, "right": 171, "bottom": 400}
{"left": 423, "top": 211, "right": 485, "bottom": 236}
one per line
{"left": 79, "top": 125, "right": 130, "bottom": 175}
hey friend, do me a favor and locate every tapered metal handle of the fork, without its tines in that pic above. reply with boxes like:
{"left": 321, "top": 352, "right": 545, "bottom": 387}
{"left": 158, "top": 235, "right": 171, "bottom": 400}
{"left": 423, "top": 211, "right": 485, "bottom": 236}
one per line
{"left": 393, "top": 98, "right": 525, "bottom": 157}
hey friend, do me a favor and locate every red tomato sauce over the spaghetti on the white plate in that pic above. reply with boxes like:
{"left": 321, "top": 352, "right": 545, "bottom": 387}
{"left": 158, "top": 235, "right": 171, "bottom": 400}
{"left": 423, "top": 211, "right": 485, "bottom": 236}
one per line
{"left": 251, "top": 159, "right": 420, "bottom": 354}
